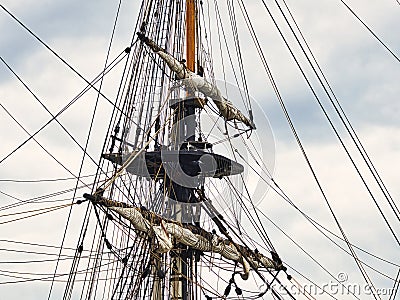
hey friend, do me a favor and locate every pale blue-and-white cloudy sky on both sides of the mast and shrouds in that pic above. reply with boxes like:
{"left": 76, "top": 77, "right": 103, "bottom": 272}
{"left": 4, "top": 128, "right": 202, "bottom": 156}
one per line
{"left": 0, "top": 0, "right": 400, "bottom": 299}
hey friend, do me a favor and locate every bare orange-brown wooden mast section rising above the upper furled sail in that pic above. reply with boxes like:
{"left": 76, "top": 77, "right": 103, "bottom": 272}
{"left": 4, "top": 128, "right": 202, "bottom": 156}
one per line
{"left": 186, "top": 0, "right": 196, "bottom": 72}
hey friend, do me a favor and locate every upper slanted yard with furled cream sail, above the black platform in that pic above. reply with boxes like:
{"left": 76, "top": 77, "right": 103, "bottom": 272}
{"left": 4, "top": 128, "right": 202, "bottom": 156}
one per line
{"left": 137, "top": 32, "right": 256, "bottom": 129}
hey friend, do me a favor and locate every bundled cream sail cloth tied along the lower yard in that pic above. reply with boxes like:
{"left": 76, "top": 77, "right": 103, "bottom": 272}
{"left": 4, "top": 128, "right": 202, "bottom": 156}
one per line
{"left": 109, "top": 207, "right": 275, "bottom": 279}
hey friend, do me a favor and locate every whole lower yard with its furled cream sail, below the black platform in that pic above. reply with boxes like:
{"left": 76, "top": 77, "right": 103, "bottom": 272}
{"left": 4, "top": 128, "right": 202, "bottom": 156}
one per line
{"left": 84, "top": 194, "right": 282, "bottom": 280}
